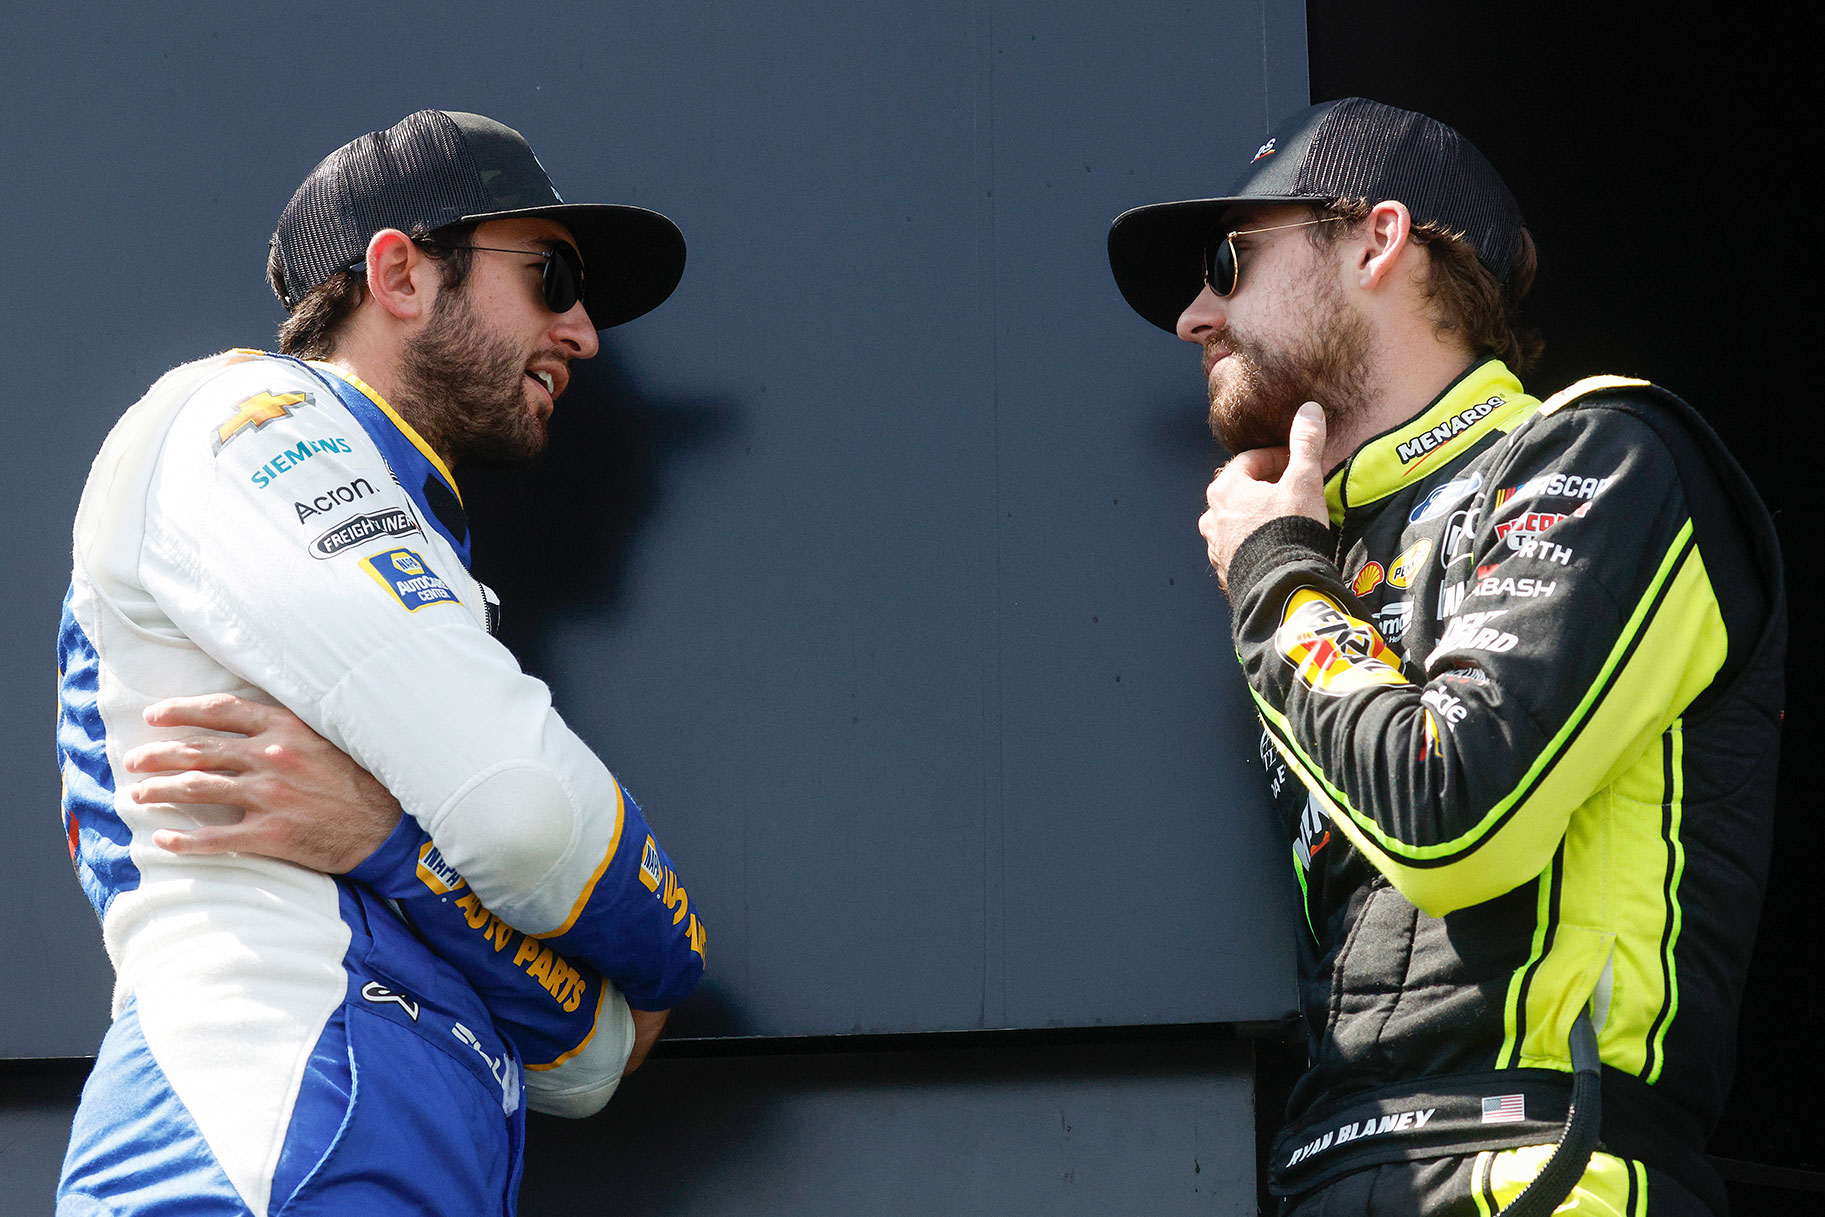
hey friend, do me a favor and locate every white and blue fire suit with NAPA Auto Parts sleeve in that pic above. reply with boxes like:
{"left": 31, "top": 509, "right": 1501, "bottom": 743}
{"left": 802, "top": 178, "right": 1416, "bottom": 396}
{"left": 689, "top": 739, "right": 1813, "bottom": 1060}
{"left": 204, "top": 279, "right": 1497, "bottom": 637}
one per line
{"left": 57, "top": 350, "right": 704, "bottom": 1217}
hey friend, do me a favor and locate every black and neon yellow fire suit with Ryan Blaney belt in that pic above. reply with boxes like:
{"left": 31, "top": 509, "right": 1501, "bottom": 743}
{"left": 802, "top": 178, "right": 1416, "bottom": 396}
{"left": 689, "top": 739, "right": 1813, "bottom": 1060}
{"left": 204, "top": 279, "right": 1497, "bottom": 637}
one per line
{"left": 1228, "top": 361, "right": 1785, "bottom": 1213}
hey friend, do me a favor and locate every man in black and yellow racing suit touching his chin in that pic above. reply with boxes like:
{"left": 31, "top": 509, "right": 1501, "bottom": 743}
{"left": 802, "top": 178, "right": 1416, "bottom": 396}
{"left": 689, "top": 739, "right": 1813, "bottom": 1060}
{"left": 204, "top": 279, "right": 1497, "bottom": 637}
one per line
{"left": 1110, "top": 99, "right": 1785, "bottom": 1217}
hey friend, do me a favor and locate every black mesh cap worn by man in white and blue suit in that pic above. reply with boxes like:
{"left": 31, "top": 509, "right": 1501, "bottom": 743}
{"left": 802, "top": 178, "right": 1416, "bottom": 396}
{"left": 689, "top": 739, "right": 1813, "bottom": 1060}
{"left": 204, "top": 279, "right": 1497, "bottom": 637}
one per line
{"left": 260, "top": 109, "right": 684, "bottom": 330}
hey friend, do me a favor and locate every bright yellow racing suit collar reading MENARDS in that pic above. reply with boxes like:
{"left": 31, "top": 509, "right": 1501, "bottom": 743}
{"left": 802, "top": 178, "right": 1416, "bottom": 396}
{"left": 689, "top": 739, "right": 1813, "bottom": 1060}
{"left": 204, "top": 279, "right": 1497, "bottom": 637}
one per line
{"left": 1325, "top": 359, "right": 1540, "bottom": 524}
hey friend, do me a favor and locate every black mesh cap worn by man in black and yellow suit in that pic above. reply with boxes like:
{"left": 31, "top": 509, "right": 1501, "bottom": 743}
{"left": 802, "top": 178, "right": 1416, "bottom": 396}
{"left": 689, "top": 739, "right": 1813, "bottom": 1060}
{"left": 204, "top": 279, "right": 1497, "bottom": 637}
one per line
{"left": 1110, "top": 97, "right": 1522, "bottom": 330}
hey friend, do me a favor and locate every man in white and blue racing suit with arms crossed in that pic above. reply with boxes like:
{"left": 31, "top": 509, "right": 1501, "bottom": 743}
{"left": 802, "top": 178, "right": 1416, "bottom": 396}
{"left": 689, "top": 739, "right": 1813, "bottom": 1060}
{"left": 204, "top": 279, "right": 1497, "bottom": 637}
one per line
{"left": 57, "top": 109, "right": 706, "bottom": 1215}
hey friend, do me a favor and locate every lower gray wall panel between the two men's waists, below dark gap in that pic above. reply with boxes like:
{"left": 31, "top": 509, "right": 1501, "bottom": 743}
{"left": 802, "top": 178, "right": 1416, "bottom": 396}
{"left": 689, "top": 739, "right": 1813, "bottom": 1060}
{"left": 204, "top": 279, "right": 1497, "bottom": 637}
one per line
{"left": 520, "top": 1044, "right": 1256, "bottom": 1217}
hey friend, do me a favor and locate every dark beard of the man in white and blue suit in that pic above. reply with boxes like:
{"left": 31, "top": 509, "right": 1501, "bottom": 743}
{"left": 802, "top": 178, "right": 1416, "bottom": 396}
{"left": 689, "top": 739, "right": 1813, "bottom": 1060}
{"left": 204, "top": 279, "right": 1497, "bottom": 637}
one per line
{"left": 396, "top": 290, "right": 546, "bottom": 469}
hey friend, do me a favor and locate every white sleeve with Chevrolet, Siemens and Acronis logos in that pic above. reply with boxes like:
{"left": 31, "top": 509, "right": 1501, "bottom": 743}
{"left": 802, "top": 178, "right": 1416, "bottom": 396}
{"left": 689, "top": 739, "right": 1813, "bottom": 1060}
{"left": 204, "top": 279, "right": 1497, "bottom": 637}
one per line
{"left": 141, "top": 359, "right": 621, "bottom": 934}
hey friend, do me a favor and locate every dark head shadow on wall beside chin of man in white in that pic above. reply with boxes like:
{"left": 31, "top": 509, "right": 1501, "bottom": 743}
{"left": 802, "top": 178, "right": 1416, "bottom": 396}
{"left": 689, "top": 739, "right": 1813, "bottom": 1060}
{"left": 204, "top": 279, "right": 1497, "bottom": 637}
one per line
{"left": 458, "top": 343, "right": 737, "bottom": 675}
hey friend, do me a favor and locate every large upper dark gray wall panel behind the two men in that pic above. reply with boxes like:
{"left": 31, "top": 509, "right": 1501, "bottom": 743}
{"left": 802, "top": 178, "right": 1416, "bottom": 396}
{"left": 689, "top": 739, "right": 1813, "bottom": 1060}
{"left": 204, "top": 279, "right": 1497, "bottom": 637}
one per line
{"left": 0, "top": 0, "right": 1305, "bottom": 1055}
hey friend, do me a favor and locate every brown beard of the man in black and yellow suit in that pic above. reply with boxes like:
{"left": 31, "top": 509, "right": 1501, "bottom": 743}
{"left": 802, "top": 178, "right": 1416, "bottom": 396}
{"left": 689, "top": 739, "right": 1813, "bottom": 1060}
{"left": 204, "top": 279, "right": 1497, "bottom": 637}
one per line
{"left": 1206, "top": 283, "right": 1369, "bottom": 454}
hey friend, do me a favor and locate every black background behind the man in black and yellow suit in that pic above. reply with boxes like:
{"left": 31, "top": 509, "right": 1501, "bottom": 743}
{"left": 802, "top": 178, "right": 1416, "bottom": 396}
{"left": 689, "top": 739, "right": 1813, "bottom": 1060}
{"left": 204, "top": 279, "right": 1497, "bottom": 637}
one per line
{"left": 1307, "top": 0, "right": 1825, "bottom": 1213}
